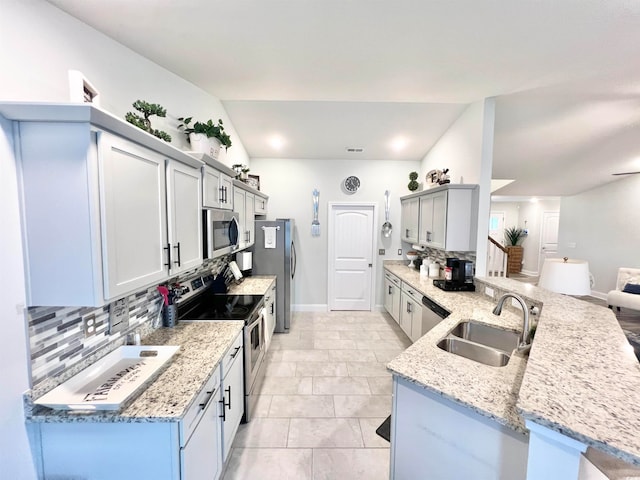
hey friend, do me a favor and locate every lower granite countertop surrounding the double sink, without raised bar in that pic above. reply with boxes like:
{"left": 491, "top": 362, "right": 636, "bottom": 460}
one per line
{"left": 384, "top": 263, "right": 527, "bottom": 433}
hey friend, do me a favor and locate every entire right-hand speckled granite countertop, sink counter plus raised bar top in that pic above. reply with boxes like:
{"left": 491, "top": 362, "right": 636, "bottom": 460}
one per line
{"left": 385, "top": 263, "right": 640, "bottom": 465}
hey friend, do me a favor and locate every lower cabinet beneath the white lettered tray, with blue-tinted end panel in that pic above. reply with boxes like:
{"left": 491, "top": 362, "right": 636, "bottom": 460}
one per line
{"left": 37, "top": 332, "right": 244, "bottom": 480}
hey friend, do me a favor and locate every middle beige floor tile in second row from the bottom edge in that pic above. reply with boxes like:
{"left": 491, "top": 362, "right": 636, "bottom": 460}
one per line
{"left": 287, "top": 418, "right": 364, "bottom": 448}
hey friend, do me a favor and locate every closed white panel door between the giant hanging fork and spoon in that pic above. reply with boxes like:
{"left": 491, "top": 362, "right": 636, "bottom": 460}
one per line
{"left": 328, "top": 204, "right": 376, "bottom": 310}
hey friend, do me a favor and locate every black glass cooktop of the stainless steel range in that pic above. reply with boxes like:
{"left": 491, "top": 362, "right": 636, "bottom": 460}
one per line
{"left": 178, "top": 292, "right": 262, "bottom": 320}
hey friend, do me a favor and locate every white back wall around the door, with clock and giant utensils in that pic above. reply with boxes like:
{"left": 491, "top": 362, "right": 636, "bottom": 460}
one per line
{"left": 251, "top": 158, "right": 419, "bottom": 310}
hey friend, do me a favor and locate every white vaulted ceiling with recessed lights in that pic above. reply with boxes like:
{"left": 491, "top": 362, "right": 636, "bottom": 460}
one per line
{"left": 49, "top": 0, "right": 640, "bottom": 195}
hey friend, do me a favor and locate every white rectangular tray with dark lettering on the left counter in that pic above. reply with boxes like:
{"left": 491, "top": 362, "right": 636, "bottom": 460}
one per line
{"left": 34, "top": 345, "right": 180, "bottom": 410}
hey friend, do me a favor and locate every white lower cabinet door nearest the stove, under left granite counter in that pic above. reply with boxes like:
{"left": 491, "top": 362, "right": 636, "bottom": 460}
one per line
{"left": 220, "top": 351, "right": 244, "bottom": 463}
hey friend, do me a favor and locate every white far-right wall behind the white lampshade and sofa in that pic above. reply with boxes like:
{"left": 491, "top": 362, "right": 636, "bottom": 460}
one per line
{"left": 558, "top": 175, "right": 640, "bottom": 297}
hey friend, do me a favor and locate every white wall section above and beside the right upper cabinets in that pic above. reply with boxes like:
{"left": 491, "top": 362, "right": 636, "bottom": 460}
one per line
{"left": 419, "top": 98, "right": 495, "bottom": 275}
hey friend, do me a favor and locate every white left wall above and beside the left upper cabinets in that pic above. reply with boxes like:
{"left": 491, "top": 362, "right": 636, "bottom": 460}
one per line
{"left": 0, "top": 0, "right": 249, "bottom": 480}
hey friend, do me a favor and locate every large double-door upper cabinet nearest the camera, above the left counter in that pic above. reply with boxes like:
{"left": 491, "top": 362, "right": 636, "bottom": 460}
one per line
{"left": 0, "top": 103, "right": 202, "bottom": 306}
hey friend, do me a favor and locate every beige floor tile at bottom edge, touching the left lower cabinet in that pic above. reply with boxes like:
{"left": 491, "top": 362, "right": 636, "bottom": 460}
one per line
{"left": 223, "top": 448, "right": 313, "bottom": 480}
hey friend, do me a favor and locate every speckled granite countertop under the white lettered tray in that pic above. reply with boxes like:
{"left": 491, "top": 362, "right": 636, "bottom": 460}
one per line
{"left": 27, "top": 321, "right": 243, "bottom": 423}
